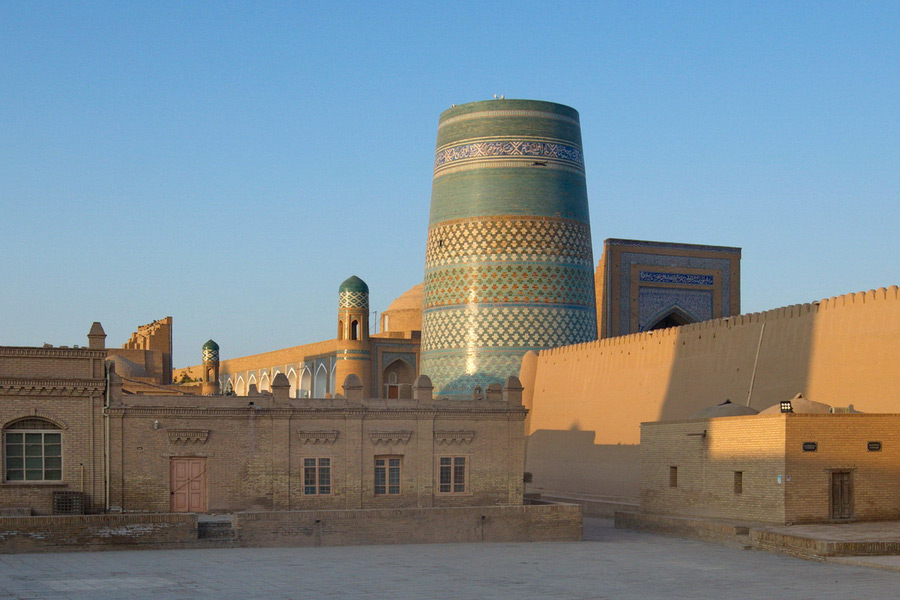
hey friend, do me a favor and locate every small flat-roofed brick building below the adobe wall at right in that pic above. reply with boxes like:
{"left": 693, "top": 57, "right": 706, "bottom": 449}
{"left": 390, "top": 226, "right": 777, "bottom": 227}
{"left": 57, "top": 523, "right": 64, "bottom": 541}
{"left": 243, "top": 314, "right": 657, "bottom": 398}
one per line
{"left": 641, "top": 412, "right": 900, "bottom": 524}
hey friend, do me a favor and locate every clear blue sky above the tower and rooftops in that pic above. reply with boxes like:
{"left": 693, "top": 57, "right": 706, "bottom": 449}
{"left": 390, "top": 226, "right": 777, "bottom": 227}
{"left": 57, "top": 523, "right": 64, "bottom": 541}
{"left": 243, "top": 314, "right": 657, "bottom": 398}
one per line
{"left": 0, "top": 0, "right": 900, "bottom": 366}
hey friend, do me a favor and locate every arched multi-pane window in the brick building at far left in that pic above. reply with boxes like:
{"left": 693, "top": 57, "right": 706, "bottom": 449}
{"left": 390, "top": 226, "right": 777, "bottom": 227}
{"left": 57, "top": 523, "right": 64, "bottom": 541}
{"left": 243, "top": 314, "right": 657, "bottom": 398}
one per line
{"left": 3, "top": 418, "right": 62, "bottom": 481}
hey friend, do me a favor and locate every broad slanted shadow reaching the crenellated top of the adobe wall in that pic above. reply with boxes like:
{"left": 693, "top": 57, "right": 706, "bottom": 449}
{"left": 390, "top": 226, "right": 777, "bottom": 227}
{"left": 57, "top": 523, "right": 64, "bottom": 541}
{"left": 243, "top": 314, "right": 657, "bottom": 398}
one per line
{"left": 659, "top": 304, "right": 816, "bottom": 421}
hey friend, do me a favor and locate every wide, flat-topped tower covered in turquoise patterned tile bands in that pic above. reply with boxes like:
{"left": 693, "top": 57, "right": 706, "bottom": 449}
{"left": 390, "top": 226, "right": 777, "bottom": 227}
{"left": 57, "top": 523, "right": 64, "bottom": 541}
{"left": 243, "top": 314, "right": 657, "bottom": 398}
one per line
{"left": 419, "top": 99, "right": 597, "bottom": 396}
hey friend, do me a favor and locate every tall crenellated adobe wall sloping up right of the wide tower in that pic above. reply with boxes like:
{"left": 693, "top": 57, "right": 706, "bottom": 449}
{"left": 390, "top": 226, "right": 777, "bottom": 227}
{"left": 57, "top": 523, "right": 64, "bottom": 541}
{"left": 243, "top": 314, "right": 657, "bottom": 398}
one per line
{"left": 520, "top": 286, "right": 900, "bottom": 497}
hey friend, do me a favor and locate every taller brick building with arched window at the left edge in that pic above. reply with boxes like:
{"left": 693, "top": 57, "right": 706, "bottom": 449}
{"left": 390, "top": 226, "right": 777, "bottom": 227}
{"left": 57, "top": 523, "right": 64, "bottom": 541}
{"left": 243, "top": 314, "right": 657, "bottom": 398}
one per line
{"left": 0, "top": 330, "right": 106, "bottom": 514}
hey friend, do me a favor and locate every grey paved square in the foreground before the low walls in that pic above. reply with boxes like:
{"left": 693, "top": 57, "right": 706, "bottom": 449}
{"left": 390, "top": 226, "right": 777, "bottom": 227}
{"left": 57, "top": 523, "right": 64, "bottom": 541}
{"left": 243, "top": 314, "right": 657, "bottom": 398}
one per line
{"left": 0, "top": 519, "right": 900, "bottom": 600}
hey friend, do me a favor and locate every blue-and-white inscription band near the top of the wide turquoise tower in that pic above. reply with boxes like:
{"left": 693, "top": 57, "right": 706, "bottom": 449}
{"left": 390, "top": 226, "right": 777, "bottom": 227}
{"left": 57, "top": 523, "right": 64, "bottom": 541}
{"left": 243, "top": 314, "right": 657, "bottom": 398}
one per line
{"left": 434, "top": 138, "right": 584, "bottom": 177}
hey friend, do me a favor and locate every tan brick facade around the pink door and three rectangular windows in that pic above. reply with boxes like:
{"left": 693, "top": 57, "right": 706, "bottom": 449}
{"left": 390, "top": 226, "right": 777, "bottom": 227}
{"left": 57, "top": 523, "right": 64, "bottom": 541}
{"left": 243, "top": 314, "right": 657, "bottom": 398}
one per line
{"left": 110, "top": 396, "right": 525, "bottom": 512}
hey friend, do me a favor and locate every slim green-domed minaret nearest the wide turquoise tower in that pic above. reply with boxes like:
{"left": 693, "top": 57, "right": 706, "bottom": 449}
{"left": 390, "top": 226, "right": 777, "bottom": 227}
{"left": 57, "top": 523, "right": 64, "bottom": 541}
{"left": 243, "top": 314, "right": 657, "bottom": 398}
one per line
{"left": 331, "top": 275, "right": 372, "bottom": 398}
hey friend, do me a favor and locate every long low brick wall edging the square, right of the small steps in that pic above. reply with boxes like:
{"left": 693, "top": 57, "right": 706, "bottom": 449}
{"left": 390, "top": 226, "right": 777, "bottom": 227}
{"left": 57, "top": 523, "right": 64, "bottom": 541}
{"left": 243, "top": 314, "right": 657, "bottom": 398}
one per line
{"left": 234, "top": 504, "right": 582, "bottom": 547}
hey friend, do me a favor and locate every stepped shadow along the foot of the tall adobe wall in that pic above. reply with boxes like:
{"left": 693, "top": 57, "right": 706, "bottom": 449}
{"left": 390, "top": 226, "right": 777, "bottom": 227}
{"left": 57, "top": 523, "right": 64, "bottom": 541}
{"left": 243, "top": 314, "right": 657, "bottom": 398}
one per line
{"left": 525, "top": 429, "right": 640, "bottom": 498}
